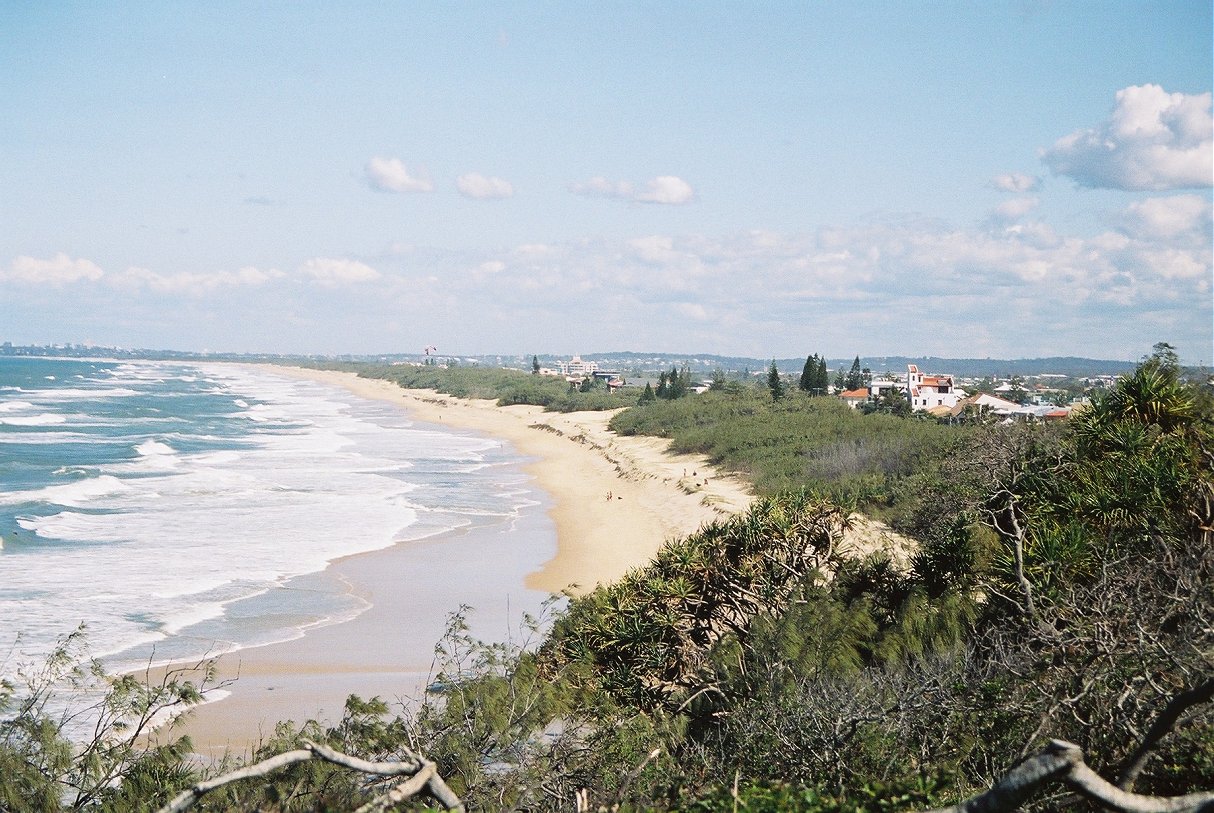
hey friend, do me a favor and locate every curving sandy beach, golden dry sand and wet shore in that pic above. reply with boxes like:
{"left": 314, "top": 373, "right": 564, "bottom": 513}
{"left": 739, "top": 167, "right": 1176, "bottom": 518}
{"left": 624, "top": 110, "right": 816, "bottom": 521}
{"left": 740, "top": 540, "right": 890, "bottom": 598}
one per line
{"left": 172, "top": 366, "right": 753, "bottom": 756}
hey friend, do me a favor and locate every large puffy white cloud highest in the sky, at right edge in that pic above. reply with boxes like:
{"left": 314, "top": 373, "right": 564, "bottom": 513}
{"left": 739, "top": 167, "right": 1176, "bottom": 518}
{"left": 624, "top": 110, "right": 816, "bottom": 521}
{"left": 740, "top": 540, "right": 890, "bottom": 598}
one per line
{"left": 1042, "top": 85, "right": 1214, "bottom": 191}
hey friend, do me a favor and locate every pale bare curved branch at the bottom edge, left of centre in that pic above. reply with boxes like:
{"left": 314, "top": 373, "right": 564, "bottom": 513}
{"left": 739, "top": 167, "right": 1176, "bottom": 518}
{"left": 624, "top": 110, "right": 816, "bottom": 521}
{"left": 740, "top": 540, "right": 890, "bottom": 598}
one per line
{"left": 158, "top": 741, "right": 464, "bottom": 813}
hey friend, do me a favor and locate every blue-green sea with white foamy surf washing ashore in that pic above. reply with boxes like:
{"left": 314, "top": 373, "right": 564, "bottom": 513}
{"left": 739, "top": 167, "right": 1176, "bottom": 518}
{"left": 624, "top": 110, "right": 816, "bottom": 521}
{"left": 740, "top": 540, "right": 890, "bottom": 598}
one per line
{"left": 0, "top": 357, "right": 555, "bottom": 677}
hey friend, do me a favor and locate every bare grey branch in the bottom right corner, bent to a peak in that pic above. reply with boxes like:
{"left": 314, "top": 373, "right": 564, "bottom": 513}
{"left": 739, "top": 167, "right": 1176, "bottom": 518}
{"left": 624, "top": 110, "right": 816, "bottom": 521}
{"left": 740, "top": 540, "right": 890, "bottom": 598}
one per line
{"left": 929, "top": 740, "right": 1214, "bottom": 813}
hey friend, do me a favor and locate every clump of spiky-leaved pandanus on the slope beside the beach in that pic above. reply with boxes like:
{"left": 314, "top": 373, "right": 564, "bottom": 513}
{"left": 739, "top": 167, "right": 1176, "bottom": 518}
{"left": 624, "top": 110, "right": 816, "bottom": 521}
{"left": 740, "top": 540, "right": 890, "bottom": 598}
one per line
{"left": 549, "top": 494, "right": 845, "bottom": 709}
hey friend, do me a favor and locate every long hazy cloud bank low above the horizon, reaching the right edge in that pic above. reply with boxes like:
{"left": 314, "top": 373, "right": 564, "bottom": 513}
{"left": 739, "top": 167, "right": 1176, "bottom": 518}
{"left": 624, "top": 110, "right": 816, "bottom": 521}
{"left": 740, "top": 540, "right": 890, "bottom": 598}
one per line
{"left": 330, "top": 207, "right": 1214, "bottom": 360}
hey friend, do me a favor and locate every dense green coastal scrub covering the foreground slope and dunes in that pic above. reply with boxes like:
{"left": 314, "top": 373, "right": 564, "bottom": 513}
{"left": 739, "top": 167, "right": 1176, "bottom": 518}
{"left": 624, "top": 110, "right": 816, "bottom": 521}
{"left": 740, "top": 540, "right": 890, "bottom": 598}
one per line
{"left": 0, "top": 357, "right": 1214, "bottom": 813}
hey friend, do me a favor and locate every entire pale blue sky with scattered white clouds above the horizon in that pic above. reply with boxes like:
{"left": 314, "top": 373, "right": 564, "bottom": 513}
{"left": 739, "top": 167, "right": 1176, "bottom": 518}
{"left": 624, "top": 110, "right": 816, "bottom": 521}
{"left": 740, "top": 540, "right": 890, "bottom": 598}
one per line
{"left": 0, "top": 0, "right": 1214, "bottom": 365}
